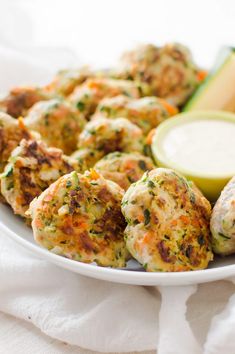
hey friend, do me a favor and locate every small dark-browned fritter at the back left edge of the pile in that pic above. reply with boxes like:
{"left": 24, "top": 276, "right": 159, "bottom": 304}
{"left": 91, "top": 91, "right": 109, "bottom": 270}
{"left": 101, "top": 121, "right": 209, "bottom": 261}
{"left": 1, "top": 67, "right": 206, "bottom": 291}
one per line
{"left": 0, "top": 86, "right": 52, "bottom": 118}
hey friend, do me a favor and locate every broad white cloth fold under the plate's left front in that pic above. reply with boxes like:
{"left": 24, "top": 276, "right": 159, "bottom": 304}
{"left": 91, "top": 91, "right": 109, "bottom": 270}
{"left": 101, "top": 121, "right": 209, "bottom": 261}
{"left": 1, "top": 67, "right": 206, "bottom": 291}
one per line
{"left": 0, "top": 235, "right": 161, "bottom": 352}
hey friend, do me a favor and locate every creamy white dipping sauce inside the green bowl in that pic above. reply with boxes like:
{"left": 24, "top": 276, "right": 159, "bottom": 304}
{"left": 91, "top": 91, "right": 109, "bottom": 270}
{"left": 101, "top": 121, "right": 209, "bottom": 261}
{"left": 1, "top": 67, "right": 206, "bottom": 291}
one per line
{"left": 162, "top": 119, "right": 235, "bottom": 176}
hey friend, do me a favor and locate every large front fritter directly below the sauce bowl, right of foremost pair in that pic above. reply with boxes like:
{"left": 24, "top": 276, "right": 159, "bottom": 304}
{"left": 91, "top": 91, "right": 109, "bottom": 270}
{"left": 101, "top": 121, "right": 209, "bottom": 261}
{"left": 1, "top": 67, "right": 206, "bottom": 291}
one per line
{"left": 122, "top": 168, "right": 213, "bottom": 272}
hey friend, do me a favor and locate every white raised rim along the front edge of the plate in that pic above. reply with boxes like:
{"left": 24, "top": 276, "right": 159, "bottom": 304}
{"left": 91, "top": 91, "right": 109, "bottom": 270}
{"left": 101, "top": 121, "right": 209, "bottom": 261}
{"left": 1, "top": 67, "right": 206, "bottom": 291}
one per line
{"left": 0, "top": 220, "right": 235, "bottom": 286}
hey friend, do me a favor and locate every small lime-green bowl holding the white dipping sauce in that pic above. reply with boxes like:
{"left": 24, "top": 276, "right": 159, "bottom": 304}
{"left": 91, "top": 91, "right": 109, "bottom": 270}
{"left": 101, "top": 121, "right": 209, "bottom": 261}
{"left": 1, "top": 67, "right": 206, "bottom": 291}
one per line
{"left": 152, "top": 110, "right": 235, "bottom": 202}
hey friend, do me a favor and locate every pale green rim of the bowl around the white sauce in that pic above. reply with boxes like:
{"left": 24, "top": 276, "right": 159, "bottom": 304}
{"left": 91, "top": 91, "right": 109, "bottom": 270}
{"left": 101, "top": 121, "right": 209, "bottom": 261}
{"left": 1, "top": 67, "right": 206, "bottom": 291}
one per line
{"left": 151, "top": 110, "right": 235, "bottom": 181}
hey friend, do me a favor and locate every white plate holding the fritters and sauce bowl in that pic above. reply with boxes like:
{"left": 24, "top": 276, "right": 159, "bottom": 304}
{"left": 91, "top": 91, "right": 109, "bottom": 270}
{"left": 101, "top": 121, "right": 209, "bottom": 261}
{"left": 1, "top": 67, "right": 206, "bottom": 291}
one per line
{"left": 0, "top": 205, "right": 235, "bottom": 286}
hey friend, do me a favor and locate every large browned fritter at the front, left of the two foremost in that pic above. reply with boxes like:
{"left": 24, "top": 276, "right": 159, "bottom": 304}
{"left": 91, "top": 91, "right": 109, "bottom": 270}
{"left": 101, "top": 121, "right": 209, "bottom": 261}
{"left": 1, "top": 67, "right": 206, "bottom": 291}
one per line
{"left": 30, "top": 170, "right": 128, "bottom": 267}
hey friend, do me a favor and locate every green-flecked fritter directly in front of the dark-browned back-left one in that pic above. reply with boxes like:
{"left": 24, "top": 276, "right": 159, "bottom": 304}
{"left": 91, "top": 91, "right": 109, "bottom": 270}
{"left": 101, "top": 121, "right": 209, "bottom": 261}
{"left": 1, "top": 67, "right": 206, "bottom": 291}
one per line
{"left": 24, "top": 98, "right": 86, "bottom": 155}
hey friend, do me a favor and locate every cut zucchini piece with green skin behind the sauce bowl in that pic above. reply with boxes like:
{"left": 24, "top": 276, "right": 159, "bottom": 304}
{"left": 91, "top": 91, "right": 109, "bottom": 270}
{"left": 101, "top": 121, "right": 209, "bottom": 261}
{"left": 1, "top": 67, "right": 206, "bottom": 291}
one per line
{"left": 183, "top": 47, "right": 235, "bottom": 112}
